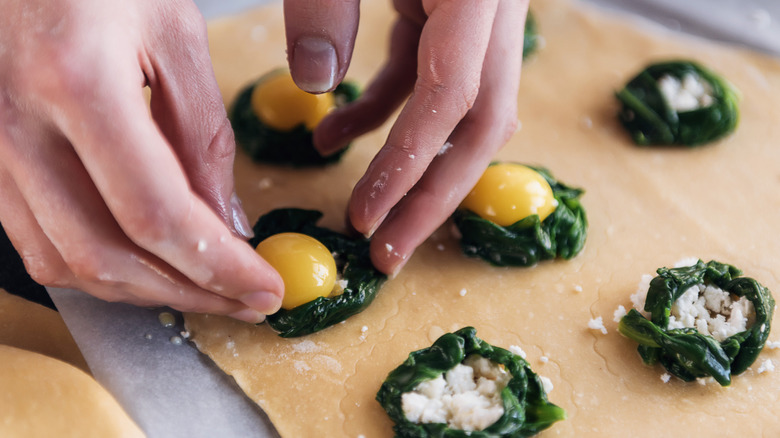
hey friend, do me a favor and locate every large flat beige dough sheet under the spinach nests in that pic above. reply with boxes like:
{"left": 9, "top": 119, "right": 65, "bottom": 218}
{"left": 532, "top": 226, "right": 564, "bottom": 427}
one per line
{"left": 186, "top": 0, "right": 780, "bottom": 438}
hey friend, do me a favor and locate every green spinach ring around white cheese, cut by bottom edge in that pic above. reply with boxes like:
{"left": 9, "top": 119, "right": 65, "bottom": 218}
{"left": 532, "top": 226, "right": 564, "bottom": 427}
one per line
{"left": 376, "top": 327, "right": 566, "bottom": 438}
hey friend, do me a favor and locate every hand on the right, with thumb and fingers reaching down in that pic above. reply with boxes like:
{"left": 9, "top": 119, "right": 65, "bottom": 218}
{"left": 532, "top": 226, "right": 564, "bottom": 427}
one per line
{"left": 284, "top": 0, "right": 528, "bottom": 274}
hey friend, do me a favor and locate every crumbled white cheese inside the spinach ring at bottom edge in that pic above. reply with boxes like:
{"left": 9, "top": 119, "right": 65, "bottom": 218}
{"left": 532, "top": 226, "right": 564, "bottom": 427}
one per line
{"left": 401, "top": 355, "right": 511, "bottom": 431}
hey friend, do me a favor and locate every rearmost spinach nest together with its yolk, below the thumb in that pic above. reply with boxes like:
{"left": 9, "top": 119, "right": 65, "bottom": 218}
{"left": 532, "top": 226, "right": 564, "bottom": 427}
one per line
{"left": 230, "top": 69, "right": 360, "bottom": 166}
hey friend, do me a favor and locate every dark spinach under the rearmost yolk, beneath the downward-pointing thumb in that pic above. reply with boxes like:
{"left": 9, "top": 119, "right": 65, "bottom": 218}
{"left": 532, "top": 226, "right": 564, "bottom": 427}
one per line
{"left": 230, "top": 70, "right": 360, "bottom": 167}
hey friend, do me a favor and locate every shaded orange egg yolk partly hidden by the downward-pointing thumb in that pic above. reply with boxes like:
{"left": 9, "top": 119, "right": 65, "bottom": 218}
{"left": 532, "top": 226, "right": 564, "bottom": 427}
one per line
{"left": 252, "top": 72, "right": 334, "bottom": 131}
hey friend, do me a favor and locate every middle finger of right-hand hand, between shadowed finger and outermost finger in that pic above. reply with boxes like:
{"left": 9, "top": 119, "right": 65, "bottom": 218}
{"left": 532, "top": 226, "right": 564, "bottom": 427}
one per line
{"left": 349, "top": 0, "right": 497, "bottom": 235}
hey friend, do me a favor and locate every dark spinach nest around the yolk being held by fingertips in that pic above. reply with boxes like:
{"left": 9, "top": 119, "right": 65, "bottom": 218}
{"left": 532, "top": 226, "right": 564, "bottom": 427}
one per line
{"left": 249, "top": 208, "right": 387, "bottom": 338}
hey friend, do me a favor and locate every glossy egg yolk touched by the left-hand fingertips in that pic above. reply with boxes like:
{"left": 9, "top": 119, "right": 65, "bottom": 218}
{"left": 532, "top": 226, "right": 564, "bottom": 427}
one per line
{"left": 255, "top": 233, "right": 337, "bottom": 310}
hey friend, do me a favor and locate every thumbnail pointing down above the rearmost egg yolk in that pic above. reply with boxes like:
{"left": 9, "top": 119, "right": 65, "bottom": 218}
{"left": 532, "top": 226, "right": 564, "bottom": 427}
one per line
{"left": 290, "top": 37, "right": 339, "bottom": 93}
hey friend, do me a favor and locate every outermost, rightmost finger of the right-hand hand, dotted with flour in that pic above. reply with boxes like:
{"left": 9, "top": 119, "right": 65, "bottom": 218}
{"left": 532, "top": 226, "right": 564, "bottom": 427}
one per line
{"left": 371, "top": 1, "right": 528, "bottom": 273}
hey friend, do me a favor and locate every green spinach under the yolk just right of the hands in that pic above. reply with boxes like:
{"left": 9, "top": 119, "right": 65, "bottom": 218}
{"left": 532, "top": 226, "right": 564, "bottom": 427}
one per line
{"left": 453, "top": 163, "right": 588, "bottom": 266}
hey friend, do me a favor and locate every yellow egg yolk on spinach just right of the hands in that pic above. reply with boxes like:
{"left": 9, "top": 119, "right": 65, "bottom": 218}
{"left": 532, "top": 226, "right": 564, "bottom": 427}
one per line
{"left": 461, "top": 163, "right": 558, "bottom": 227}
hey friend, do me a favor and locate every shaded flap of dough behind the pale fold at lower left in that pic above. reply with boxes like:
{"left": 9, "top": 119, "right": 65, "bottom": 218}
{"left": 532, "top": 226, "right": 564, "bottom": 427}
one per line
{"left": 0, "top": 289, "right": 90, "bottom": 373}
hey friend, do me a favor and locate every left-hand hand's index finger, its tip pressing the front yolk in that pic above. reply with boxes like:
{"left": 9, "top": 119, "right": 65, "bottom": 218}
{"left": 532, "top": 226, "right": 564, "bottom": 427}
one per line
{"left": 46, "top": 54, "right": 284, "bottom": 313}
